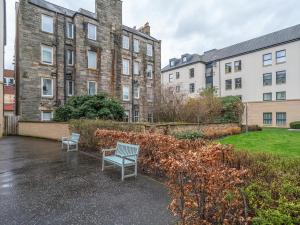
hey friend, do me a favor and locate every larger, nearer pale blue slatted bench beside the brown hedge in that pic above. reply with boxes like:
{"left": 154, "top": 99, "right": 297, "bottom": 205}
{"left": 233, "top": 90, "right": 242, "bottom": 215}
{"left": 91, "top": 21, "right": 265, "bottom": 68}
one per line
{"left": 102, "top": 142, "right": 140, "bottom": 181}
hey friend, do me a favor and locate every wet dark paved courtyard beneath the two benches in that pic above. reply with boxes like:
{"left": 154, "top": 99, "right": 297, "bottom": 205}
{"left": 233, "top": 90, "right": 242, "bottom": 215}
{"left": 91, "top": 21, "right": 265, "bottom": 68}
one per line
{"left": 0, "top": 137, "right": 174, "bottom": 225}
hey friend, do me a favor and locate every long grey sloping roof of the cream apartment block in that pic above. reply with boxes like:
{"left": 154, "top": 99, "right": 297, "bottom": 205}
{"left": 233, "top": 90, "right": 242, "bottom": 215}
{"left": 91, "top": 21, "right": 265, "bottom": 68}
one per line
{"left": 162, "top": 24, "right": 300, "bottom": 72}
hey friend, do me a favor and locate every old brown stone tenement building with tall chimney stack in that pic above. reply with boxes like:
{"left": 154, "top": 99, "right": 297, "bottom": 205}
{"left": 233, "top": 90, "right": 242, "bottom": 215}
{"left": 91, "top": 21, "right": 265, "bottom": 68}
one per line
{"left": 16, "top": 0, "right": 161, "bottom": 122}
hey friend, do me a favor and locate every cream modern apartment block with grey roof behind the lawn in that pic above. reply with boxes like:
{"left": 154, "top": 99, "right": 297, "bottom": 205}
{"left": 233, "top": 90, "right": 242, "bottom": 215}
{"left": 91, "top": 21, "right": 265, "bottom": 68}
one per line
{"left": 162, "top": 25, "right": 300, "bottom": 127}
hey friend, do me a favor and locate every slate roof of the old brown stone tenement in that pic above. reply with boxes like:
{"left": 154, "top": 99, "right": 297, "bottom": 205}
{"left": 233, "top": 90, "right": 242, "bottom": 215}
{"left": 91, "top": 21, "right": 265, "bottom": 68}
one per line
{"left": 29, "top": 0, "right": 158, "bottom": 41}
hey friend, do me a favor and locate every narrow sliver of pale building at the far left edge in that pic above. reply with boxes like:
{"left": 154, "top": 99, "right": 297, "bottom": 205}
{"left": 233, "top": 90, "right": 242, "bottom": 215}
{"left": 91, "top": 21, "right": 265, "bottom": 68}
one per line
{"left": 0, "top": 0, "right": 6, "bottom": 137}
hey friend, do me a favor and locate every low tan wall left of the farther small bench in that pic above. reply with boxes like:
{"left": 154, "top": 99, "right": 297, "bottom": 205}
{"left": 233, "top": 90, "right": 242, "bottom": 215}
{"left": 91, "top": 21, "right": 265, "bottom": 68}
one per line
{"left": 18, "top": 121, "right": 70, "bottom": 140}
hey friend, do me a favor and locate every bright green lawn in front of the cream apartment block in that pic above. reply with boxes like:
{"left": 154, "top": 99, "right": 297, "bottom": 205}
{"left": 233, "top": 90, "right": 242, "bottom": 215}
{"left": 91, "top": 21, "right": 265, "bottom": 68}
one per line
{"left": 220, "top": 128, "right": 300, "bottom": 157}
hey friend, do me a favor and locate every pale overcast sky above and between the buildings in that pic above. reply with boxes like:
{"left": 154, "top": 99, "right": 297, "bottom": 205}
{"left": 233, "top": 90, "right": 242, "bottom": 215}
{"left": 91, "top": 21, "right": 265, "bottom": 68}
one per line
{"left": 5, "top": 0, "right": 300, "bottom": 68}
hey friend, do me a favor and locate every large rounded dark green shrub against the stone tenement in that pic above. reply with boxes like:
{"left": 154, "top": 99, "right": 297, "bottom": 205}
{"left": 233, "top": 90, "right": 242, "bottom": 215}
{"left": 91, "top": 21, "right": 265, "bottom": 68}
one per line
{"left": 54, "top": 94, "right": 124, "bottom": 122}
